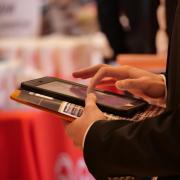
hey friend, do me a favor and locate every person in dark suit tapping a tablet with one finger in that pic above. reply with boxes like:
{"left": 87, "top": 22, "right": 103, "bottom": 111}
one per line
{"left": 67, "top": 1, "right": 180, "bottom": 180}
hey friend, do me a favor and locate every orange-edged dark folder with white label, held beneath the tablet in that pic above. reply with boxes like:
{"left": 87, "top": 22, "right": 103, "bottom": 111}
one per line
{"left": 11, "top": 89, "right": 164, "bottom": 122}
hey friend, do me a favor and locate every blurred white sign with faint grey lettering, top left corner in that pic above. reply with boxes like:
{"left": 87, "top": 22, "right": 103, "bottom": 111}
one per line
{"left": 0, "top": 0, "right": 41, "bottom": 38}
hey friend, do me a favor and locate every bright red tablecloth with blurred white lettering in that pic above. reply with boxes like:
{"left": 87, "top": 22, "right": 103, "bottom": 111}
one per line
{"left": 0, "top": 111, "right": 93, "bottom": 180}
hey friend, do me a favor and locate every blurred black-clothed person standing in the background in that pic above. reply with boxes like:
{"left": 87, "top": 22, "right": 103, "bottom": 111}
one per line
{"left": 96, "top": 0, "right": 159, "bottom": 62}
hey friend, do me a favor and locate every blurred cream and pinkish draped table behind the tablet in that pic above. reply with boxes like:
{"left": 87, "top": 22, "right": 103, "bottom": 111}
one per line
{"left": 0, "top": 33, "right": 109, "bottom": 110}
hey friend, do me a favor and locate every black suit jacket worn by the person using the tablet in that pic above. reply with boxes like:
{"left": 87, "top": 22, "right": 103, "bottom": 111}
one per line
{"left": 84, "top": 2, "right": 180, "bottom": 180}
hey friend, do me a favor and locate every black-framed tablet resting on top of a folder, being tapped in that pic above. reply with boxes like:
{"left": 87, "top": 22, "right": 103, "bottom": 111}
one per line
{"left": 21, "top": 77, "right": 147, "bottom": 116}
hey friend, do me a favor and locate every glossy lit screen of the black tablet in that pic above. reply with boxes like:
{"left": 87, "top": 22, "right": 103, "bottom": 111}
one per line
{"left": 37, "top": 81, "right": 134, "bottom": 109}
